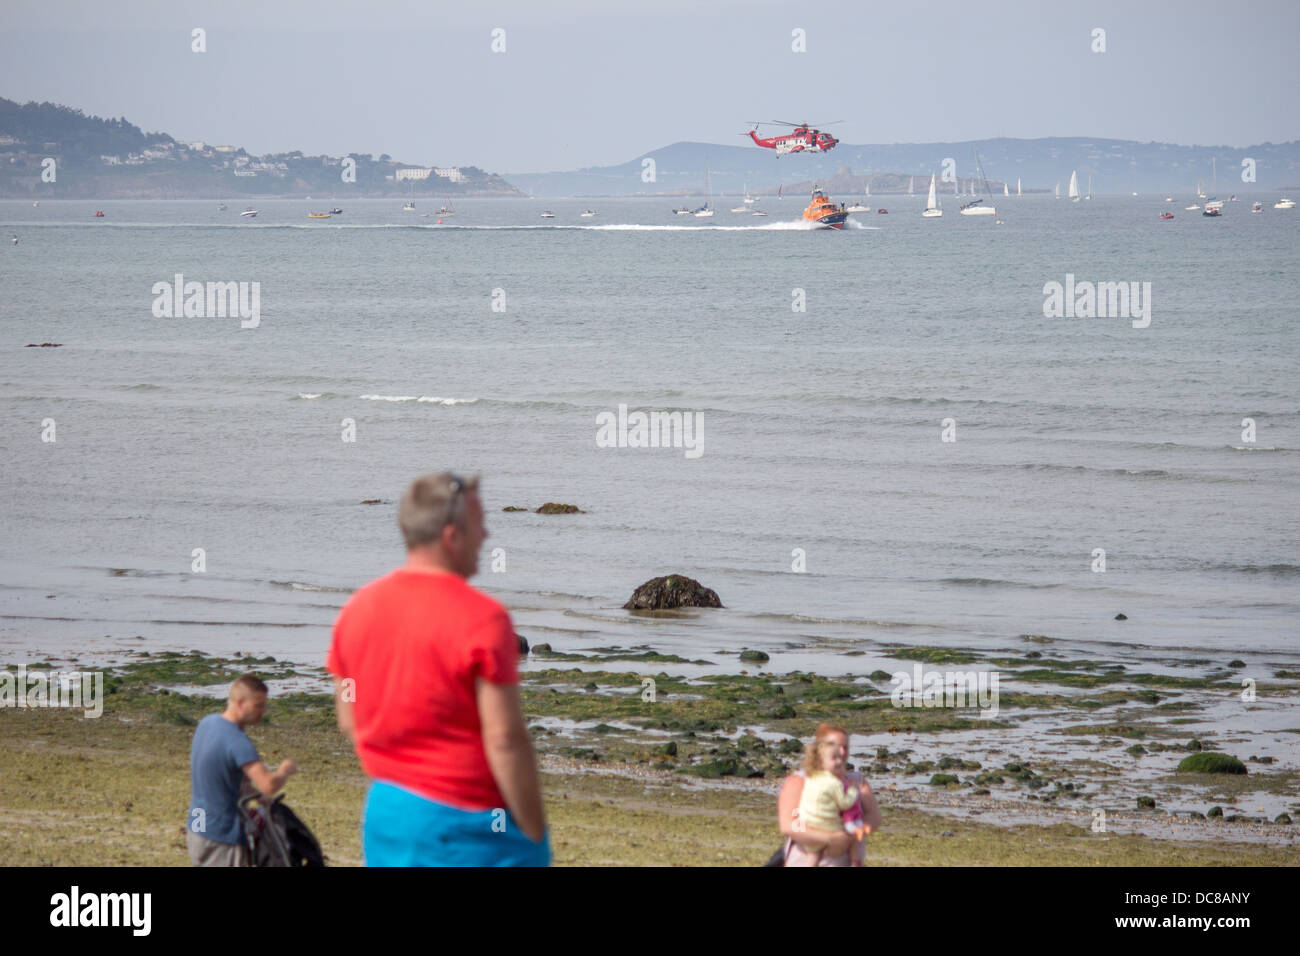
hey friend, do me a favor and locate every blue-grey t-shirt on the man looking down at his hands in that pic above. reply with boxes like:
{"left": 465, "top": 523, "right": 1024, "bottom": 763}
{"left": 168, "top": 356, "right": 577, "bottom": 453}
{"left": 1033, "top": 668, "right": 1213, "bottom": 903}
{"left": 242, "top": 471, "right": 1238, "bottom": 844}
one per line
{"left": 186, "top": 714, "right": 259, "bottom": 844}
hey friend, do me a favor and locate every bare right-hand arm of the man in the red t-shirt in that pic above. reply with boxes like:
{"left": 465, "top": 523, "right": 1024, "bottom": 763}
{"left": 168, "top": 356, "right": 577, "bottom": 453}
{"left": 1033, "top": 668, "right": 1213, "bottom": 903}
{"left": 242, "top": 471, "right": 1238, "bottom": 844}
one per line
{"left": 475, "top": 678, "right": 546, "bottom": 843}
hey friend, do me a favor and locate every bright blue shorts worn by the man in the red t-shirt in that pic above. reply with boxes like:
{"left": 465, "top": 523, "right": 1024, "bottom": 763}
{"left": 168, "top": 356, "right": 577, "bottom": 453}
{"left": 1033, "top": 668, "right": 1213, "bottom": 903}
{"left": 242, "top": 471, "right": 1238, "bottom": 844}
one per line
{"left": 361, "top": 780, "right": 551, "bottom": 866}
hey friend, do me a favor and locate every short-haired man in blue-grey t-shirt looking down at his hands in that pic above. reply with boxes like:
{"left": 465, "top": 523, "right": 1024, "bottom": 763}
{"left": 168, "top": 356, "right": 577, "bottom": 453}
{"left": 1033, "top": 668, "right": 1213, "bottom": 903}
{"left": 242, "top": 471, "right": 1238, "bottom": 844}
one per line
{"left": 186, "top": 674, "right": 298, "bottom": 866}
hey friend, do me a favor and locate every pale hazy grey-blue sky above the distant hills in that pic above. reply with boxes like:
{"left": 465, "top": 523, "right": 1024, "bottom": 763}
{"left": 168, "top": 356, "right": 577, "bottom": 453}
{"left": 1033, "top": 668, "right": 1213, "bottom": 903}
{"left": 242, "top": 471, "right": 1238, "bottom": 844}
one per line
{"left": 0, "top": 0, "right": 1300, "bottom": 173}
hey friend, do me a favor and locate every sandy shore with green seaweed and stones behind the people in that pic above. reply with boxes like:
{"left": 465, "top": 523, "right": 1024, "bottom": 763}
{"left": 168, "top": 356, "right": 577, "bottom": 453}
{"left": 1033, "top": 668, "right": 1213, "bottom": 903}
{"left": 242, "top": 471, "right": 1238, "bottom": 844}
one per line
{"left": 0, "top": 654, "right": 1300, "bottom": 865}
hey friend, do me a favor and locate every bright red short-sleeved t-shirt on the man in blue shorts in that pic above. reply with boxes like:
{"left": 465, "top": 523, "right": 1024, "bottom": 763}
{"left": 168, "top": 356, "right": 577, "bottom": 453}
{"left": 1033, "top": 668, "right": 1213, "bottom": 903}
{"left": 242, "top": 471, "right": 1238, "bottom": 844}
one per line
{"left": 325, "top": 567, "right": 519, "bottom": 810}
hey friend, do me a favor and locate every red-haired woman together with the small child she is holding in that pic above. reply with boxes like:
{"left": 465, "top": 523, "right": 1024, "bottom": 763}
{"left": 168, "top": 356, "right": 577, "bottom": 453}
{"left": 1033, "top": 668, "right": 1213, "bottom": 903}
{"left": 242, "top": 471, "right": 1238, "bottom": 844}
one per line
{"left": 776, "top": 723, "right": 880, "bottom": 866}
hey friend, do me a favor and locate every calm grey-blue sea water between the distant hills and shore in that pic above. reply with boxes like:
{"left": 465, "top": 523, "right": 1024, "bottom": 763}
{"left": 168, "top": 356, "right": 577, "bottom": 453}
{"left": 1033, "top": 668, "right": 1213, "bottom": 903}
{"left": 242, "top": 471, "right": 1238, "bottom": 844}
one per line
{"left": 0, "top": 196, "right": 1300, "bottom": 674}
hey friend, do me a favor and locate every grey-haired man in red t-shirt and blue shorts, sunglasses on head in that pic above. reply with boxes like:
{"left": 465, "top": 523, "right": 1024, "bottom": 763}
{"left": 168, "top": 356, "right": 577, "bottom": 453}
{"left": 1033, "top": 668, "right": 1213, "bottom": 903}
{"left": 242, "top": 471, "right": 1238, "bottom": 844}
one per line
{"left": 325, "top": 472, "right": 550, "bottom": 866}
